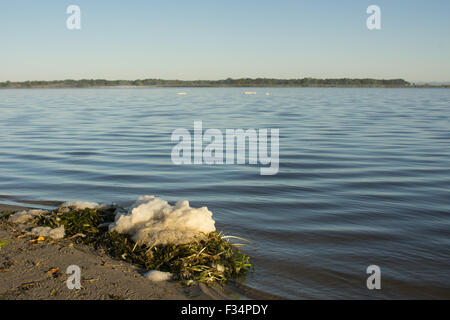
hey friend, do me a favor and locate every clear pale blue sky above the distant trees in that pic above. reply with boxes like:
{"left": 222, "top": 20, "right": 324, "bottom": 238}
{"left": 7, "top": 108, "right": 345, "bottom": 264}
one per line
{"left": 0, "top": 0, "right": 450, "bottom": 81}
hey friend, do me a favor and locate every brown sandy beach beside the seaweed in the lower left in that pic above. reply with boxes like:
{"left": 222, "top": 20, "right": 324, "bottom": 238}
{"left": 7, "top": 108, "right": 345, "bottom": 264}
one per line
{"left": 0, "top": 204, "right": 236, "bottom": 300}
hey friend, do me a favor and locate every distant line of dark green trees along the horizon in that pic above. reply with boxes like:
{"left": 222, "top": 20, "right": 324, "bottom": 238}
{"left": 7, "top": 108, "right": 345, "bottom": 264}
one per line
{"left": 0, "top": 78, "right": 432, "bottom": 88}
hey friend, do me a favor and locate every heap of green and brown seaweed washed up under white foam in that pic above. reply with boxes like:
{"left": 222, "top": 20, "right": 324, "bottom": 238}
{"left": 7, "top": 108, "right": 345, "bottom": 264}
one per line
{"left": 2, "top": 207, "right": 253, "bottom": 285}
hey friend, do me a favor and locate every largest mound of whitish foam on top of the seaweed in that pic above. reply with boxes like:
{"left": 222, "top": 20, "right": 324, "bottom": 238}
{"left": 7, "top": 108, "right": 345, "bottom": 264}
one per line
{"left": 109, "top": 196, "right": 216, "bottom": 247}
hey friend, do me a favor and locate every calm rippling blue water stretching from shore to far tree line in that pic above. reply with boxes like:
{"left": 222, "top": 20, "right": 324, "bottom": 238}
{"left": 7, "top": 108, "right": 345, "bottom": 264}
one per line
{"left": 0, "top": 88, "right": 450, "bottom": 298}
